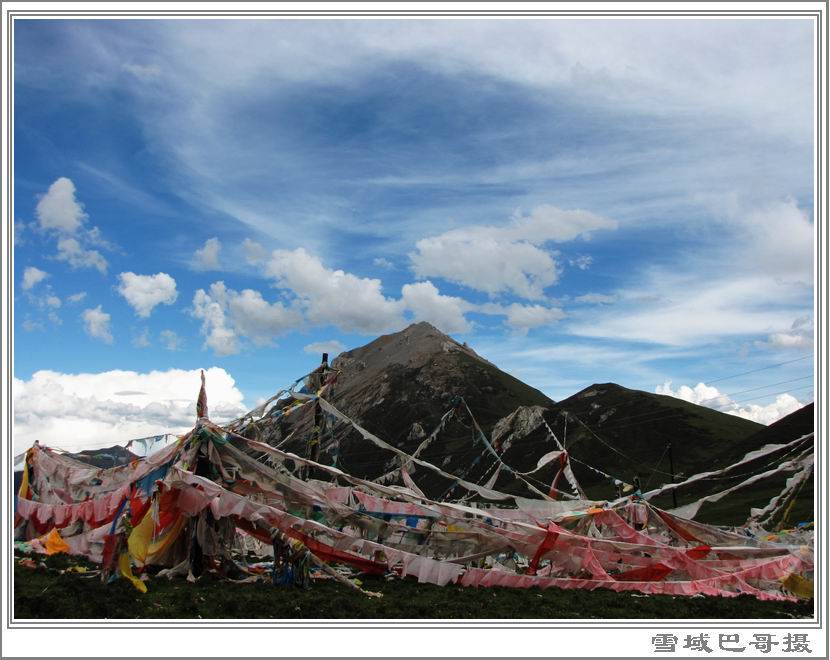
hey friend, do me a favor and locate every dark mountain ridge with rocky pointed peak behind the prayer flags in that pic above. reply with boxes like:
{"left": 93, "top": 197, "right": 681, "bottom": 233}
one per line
{"left": 248, "top": 323, "right": 816, "bottom": 517}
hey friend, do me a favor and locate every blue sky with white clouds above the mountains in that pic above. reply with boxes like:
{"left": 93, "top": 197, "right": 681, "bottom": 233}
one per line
{"left": 13, "top": 19, "right": 814, "bottom": 451}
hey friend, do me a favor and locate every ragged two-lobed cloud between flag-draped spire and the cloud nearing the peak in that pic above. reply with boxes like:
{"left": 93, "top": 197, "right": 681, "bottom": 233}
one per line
{"left": 191, "top": 282, "right": 302, "bottom": 355}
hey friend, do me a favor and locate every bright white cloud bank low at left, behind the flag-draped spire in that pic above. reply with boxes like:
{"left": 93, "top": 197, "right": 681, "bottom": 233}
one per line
{"left": 13, "top": 367, "right": 246, "bottom": 453}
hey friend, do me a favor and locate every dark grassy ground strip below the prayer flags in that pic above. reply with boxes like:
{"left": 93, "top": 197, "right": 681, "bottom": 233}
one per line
{"left": 14, "top": 556, "right": 813, "bottom": 620}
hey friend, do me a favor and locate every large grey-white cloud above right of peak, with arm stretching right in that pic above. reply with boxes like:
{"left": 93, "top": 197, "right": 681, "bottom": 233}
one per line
{"left": 409, "top": 205, "right": 617, "bottom": 300}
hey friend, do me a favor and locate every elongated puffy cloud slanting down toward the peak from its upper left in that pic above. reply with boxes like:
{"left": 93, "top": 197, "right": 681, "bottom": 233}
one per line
{"left": 266, "top": 248, "right": 403, "bottom": 333}
